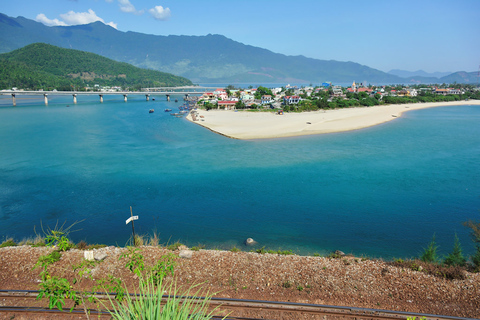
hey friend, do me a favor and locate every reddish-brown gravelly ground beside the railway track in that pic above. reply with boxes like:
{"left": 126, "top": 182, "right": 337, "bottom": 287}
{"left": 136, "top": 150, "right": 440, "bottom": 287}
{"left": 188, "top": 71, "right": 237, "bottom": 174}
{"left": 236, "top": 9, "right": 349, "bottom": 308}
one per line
{"left": 0, "top": 246, "right": 480, "bottom": 318}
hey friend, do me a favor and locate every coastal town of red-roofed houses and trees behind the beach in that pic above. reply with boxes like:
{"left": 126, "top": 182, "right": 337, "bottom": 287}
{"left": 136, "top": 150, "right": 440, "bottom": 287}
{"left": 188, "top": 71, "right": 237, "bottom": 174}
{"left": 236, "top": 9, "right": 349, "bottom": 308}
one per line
{"left": 196, "top": 81, "right": 480, "bottom": 111}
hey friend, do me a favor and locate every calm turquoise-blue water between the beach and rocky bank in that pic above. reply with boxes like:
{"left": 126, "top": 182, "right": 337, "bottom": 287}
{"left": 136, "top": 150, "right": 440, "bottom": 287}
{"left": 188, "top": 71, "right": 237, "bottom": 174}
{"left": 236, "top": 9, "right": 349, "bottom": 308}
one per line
{"left": 0, "top": 96, "right": 480, "bottom": 258}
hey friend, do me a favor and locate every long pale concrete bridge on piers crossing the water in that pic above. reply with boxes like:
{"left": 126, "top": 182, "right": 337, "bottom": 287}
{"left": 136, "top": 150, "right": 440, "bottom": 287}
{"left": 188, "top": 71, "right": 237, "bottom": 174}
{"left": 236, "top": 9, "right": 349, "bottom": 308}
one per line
{"left": 0, "top": 86, "right": 216, "bottom": 106}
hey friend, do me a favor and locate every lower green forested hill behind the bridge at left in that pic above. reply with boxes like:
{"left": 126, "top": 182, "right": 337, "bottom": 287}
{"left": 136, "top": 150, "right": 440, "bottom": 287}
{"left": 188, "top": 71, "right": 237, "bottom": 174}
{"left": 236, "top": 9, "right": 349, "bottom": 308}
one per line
{"left": 0, "top": 43, "right": 192, "bottom": 90}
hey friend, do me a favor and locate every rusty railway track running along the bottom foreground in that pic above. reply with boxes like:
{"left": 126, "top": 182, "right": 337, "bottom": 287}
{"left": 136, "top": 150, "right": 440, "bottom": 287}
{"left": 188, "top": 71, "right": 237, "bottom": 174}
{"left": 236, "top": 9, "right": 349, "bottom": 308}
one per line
{"left": 0, "top": 290, "right": 474, "bottom": 320}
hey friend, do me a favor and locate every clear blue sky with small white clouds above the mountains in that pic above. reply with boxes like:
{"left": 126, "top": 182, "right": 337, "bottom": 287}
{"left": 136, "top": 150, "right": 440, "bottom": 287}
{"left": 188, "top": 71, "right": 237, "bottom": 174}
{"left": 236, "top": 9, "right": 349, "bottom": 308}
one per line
{"left": 0, "top": 0, "right": 480, "bottom": 72}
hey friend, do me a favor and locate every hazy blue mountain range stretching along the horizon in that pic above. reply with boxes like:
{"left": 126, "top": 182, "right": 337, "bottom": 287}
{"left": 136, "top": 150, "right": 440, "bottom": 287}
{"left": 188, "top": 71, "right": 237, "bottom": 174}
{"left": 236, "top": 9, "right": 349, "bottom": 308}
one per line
{"left": 0, "top": 14, "right": 477, "bottom": 84}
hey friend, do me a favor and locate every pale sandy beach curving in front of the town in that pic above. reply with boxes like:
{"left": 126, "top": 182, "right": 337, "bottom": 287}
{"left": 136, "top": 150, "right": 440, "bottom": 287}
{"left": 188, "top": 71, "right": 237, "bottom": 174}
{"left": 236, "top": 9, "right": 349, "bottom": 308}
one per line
{"left": 187, "top": 100, "right": 480, "bottom": 140}
